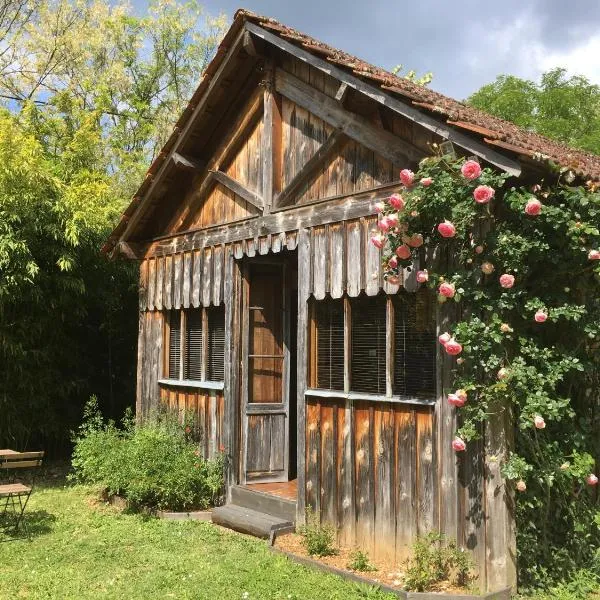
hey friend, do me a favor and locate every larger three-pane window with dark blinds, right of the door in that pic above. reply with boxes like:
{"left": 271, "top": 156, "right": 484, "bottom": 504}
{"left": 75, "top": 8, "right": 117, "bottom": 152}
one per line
{"left": 310, "top": 288, "right": 437, "bottom": 400}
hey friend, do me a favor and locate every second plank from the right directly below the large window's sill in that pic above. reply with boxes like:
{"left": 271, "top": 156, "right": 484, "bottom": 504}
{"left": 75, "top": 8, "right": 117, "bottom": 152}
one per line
{"left": 394, "top": 405, "right": 417, "bottom": 560}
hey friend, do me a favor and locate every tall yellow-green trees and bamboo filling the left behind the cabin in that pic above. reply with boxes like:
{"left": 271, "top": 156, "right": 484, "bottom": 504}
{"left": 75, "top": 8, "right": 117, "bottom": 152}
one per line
{"left": 0, "top": 0, "right": 224, "bottom": 450}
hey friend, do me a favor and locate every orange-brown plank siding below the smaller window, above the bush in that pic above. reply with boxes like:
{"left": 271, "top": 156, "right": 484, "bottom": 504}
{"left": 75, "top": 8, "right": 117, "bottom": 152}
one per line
{"left": 160, "top": 385, "right": 226, "bottom": 458}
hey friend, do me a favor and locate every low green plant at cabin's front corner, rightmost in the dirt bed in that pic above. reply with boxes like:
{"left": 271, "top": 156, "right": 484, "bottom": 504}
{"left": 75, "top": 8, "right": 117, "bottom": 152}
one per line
{"left": 404, "top": 532, "right": 473, "bottom": 592}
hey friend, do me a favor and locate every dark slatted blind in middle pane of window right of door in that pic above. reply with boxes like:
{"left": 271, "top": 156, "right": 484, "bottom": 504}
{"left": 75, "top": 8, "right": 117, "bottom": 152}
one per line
{"left": 350, "top": 295, "right": 386, "bottom": 394}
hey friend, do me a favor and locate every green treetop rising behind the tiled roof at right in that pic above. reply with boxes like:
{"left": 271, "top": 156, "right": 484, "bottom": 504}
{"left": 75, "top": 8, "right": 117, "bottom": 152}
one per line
{"left": 467, "top": 68, "right": 600, "bottom": 154}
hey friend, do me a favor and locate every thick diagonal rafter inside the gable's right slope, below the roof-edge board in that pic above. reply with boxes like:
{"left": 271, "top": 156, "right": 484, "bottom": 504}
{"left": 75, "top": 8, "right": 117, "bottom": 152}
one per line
{"left": 275, "top": 69, "right": 423, "bottom": 163}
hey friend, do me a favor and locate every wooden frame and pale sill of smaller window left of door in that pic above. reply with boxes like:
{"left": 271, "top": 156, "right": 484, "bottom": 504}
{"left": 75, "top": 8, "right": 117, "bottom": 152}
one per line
{"left": 158, "top": 304, "right": 226, "bottom": 390}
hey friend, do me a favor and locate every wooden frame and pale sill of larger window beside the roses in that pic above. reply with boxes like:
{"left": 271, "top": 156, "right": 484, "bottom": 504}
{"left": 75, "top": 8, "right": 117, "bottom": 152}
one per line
{"left": 305, "top": 292, "right": 440, "bottom": 406}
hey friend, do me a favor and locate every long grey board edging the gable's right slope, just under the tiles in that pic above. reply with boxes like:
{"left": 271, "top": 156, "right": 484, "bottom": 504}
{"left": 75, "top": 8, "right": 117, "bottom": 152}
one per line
{"left": 245, "top": 23, "right": 521, "bottom": 177}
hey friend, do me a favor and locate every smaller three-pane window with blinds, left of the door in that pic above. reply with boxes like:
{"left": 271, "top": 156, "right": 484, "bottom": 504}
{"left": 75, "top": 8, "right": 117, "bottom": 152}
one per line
{"left": 165, "top": 306, "right": 225, "bottom": 382}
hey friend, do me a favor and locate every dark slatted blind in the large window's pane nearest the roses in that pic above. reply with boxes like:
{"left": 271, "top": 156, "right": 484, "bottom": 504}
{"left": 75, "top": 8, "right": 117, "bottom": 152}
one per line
{"left": 392, "top": 288, "right": 436, "bottom": 400}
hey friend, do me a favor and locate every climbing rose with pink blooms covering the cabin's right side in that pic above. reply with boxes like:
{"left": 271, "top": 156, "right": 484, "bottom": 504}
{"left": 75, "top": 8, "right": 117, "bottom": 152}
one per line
{"left": 372, "top": 155, "right": 600, "bottom": 585}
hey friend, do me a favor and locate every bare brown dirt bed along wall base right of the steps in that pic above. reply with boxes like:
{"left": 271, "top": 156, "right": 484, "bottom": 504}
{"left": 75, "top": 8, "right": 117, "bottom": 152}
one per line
{"left": 275, "top": 533, "right": 472, "bottom": 594}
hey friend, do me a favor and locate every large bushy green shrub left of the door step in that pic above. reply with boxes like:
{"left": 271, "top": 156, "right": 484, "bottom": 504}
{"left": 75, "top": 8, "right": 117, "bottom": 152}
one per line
{"left": 72, "top": 398, "right": 224, "bottom": 510}
